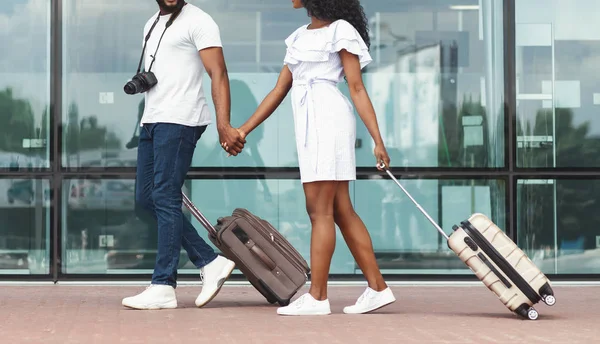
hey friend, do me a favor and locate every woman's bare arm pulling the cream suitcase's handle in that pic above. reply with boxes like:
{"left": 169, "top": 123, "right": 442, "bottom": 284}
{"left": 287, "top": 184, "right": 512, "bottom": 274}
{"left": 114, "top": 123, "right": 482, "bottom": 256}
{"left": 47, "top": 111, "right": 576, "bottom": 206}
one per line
{"left": 340, "top": 50, "right": 390, "bottom": 167}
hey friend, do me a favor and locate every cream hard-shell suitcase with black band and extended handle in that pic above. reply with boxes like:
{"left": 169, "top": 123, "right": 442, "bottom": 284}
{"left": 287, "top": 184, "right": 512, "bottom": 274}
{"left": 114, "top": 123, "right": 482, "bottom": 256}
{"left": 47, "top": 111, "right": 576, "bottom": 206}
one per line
{"left": 381, "top": 164, "right": 556, "bottom": 320}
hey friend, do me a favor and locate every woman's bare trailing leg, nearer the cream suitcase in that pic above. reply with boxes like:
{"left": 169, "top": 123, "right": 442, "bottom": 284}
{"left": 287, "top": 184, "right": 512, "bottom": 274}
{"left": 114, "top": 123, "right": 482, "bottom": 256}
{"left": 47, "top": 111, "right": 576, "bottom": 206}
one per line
{"left": 333, "top": 181, "right": 387, "bottom": 291}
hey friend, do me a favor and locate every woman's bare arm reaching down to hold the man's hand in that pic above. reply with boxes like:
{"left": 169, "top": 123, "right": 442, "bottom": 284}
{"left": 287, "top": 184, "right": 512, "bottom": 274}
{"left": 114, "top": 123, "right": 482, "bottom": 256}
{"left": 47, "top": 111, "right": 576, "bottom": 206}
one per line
{"left": 239, "top": 66, "right": 292, "bottom": 138}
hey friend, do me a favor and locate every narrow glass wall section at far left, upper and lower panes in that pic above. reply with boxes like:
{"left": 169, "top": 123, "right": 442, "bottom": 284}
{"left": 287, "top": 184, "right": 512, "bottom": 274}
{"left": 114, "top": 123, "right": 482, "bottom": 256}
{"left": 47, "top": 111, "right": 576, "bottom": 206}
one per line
{"left": 0, "top": 1, "right": 50, "bottom": 275}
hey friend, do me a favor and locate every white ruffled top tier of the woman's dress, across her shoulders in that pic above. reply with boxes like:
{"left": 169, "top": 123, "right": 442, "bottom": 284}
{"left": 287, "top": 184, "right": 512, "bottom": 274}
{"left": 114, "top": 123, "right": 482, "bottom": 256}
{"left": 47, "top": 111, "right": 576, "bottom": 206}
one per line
{"left": 284, "top": 20, "right": 373, "bottom": 69}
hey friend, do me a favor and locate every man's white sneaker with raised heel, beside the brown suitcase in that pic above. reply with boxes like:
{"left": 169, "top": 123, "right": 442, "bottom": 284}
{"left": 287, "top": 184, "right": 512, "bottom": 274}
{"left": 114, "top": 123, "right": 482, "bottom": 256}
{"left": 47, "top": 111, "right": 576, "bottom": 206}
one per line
{"left": 196, "top": 256, "right": 235, "bottom": 307}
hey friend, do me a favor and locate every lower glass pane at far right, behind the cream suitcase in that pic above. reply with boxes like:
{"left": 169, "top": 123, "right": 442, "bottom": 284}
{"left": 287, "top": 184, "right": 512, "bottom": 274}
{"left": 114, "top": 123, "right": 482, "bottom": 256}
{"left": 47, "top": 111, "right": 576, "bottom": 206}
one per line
{"left": 517, "top": 179, "right": 600, "bottom": 274}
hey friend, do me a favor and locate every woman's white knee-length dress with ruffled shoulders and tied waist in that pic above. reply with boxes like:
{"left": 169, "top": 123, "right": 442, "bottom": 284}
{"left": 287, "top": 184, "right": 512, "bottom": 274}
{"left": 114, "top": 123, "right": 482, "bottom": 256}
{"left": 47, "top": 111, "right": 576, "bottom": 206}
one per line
{"left": 284, "top": 20, "right": 372, "bottom": 183}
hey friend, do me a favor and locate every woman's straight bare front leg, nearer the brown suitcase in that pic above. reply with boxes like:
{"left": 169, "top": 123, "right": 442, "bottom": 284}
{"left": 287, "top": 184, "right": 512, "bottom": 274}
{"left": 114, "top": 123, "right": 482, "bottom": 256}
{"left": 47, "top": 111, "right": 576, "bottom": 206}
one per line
{"left": 303, "top": 181, "right": 338, "bottom": 301}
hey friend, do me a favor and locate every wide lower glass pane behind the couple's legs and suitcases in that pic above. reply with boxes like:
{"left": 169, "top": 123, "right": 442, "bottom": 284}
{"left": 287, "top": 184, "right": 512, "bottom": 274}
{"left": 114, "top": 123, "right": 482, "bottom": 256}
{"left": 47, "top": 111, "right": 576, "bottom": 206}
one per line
{"left": 63, "top": 179, "right": 506, "bottom": 274}
